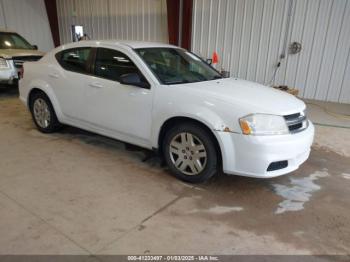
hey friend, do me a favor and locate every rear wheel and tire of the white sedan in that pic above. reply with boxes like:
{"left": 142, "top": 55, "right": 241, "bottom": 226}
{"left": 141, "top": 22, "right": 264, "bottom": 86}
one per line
{"left": 30, "top": 92, "right": 61, "bottom": 133}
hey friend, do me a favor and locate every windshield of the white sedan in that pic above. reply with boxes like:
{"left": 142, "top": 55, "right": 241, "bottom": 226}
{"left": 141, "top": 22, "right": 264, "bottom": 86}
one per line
{"left": 135, "top": 48, "right": 222, "bottom": 85}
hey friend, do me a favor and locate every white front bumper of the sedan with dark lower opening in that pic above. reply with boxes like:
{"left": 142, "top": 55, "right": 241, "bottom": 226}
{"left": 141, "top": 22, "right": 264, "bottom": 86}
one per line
{"left": 216, "top": 121, "right": 315, "bottom": 178}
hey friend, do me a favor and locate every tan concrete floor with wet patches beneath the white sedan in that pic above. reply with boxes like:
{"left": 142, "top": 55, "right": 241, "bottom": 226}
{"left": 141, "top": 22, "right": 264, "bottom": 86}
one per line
{"left": 0, "top": 89, "right": 350, "bottom": 254}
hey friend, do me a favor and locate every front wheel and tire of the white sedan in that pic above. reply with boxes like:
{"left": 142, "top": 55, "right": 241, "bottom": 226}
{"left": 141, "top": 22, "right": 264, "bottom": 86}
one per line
{"left": 163, "top": 123, "right": 218, "bottom": 183}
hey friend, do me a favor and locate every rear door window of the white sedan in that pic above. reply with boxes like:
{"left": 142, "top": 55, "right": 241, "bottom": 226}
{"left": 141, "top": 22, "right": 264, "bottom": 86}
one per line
{"left": 56, "top": 47, "right": 91, "bottom": 74}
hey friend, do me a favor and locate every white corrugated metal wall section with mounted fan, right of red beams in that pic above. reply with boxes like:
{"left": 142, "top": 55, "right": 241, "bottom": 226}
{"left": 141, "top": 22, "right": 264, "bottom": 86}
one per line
{"left": 192, "top": 0, "right": 350, "bottom": 103}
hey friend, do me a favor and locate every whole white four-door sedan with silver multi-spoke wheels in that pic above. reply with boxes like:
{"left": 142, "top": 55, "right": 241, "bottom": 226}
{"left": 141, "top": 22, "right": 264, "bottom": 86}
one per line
{"left": 19, "top": 41, "right": 314, "bottom": 182}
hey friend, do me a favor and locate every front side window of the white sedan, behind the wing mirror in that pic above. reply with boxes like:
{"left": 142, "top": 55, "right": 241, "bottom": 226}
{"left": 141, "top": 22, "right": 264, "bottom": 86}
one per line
{"left": 95, "top": 48, "right": 142, "bottom": 82}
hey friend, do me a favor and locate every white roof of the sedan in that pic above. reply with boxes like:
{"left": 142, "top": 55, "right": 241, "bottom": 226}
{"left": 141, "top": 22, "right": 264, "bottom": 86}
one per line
{"left": 60, "top": 40, "right": 178, "bottom": 48}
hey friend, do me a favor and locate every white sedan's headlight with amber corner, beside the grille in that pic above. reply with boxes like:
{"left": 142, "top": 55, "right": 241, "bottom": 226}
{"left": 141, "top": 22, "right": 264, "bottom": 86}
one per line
{"left": 239, "top": 114, "right": 289, "bottom": 136}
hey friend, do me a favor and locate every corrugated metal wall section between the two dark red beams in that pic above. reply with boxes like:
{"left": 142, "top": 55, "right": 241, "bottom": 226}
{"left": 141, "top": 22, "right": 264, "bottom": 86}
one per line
{"left": 57, "top": 0, "right": 168, "bottom": 43}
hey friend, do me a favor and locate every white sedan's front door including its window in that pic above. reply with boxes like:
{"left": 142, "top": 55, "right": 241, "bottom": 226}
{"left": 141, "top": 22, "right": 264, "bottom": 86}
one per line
{"left": 84, "top": 48, "right": 152, "bottom": 146}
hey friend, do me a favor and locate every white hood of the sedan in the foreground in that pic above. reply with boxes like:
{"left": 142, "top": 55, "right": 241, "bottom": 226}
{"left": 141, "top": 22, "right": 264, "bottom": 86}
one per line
{"left": 186, "top": 78, "right": 305, "bottom": 115}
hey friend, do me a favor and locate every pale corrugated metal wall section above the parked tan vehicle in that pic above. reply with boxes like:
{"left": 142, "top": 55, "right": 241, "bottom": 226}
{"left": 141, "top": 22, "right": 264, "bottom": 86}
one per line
{"left": 0, "top": 0, "right": 54, "bottom": 51}
